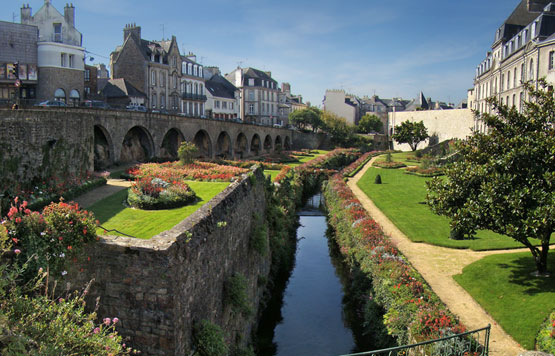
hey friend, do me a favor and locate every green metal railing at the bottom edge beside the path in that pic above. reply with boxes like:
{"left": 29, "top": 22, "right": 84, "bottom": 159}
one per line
{"left": 341, "top": 325, "right": 491, "bottom": 356}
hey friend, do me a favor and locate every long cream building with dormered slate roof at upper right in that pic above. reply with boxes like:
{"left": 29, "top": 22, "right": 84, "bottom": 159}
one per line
{"left": 468, "top": 0, "right": 555, "bottom": 132}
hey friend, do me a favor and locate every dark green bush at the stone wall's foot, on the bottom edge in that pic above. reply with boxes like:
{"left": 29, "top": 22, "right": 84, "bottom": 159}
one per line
{"left": 193, "top": 320, "right": 229, "bottom": 356}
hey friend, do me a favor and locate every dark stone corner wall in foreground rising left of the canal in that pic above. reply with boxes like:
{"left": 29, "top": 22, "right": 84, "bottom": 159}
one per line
{"left": 68, "top": 170, "right": 271, "bottom": 356}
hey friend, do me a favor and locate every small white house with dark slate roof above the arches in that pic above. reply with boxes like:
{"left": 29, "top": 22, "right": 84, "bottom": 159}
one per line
{"left": 204, "top": 67, "right": 241, "bottom": 120}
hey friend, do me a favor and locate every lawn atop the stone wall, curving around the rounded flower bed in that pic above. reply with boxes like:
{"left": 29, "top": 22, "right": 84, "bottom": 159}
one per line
{"left": 88, "top": 181, "right": 229, "bottom": 239}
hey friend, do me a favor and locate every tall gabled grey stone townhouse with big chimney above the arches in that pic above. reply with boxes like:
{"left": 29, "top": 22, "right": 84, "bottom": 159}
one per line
{"left": 110, "top": 24, "right": 206, "bottom": 116}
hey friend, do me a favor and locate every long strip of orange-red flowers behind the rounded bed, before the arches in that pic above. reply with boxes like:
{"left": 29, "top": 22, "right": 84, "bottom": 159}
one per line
{"left": 124, "top": 162, "right": 248, "bottom": 182}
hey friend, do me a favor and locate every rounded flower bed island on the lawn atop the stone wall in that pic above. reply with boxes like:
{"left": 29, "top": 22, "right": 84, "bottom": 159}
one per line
{"left": 127, "top": 177, "right": 197, "bottom": 210}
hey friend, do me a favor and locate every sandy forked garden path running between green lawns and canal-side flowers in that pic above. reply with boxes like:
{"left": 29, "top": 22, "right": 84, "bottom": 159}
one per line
{"left": 347, "top": 157, "right": 528, "bottom": 356}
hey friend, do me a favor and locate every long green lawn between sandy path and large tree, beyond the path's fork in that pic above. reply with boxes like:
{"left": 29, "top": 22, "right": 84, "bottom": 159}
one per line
{"left": 358, "top": 167, "right": 536, "bottom": 250}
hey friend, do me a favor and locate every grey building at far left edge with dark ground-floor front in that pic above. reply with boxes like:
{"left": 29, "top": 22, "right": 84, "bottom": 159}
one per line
{"left": 0, "top": 21, "right": 38, "bottom": 106}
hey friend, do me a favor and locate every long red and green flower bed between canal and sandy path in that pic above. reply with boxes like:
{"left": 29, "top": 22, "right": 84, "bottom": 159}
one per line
{"left": 324, "top": 159, "right": 464, "bottom": 344}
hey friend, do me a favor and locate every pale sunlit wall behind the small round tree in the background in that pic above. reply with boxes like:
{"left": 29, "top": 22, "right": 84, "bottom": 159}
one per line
{"left": 389, "top": 109, "right": 474, "bottom": 151}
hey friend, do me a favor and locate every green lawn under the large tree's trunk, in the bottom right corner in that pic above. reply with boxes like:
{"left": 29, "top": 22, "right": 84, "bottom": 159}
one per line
{"left": 453, "top": 251, "right": 555, "bottom": 350}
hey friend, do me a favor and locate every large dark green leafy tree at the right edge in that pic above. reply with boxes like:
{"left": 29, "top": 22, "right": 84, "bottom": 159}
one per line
{"left": 426, "top": 80, "right": 555, "bottom": 275}
